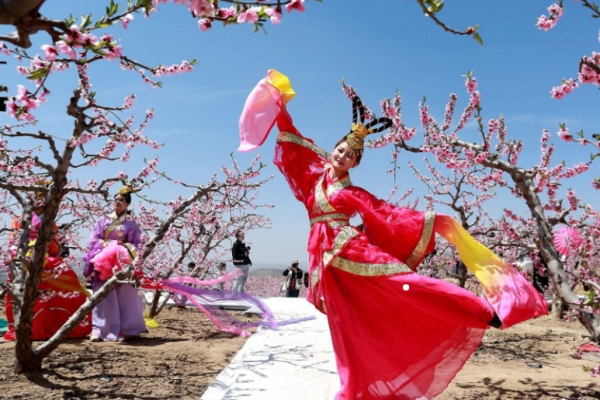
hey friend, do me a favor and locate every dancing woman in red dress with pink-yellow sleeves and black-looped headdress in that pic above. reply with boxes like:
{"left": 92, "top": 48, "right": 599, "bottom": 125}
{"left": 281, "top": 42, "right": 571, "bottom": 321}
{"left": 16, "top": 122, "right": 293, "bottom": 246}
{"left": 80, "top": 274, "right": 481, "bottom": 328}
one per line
{"left": 240, "top": 70, "right": 547, "bottom": 400}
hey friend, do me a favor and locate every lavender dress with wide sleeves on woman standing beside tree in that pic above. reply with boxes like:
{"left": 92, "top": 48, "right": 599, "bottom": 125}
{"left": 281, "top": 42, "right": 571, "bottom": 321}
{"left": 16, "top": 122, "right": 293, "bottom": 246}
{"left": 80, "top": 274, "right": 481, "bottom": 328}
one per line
{"left": 83, "top": 212, "right": 146, "bottom": 341}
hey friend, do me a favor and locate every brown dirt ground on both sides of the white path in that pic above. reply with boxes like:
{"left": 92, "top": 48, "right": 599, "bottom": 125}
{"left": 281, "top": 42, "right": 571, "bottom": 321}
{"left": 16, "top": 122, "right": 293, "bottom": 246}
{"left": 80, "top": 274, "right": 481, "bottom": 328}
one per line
{"left": 0, "top": 296, "right": 600, "bottom": 400}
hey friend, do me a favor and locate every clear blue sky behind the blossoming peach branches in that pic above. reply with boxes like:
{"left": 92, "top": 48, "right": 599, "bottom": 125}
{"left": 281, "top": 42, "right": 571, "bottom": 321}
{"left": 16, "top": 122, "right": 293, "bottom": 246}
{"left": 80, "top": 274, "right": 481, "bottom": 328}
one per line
{"left": 0, "top": 0, "right": 600, "bottom": 267}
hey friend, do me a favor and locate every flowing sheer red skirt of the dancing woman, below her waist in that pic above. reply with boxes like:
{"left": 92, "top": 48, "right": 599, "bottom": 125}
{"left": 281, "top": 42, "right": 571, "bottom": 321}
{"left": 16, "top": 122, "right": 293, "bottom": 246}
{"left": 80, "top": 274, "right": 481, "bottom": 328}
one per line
{"left": 321, "top": 234, "right": 494, "bottom": 400}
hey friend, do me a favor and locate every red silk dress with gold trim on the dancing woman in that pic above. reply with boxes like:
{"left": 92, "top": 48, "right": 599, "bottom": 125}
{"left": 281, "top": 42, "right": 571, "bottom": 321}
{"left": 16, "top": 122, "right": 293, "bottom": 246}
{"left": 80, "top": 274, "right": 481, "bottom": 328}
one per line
{"left": 274, "top": 110, "right": 493, "bottom": 400}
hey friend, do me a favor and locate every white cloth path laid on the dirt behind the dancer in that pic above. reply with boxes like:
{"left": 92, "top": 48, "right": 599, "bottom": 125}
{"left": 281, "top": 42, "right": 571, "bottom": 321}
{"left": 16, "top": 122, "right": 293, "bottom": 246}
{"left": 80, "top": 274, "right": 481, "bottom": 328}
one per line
{"left": 201, "top": 298, "right": 340, "bottom": 400}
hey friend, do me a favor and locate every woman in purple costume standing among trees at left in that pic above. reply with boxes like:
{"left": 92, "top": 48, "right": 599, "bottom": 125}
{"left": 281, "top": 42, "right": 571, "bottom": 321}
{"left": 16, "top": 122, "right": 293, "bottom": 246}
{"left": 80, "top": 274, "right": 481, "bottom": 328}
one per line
{"left": 83, "top": 186, "right": 147, "bottom": 342}
